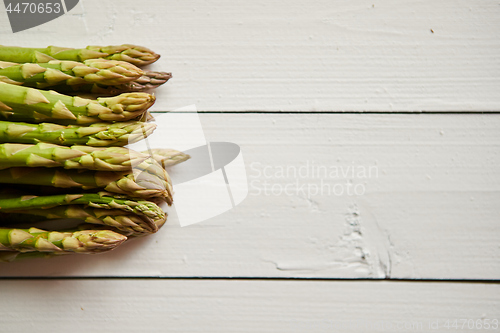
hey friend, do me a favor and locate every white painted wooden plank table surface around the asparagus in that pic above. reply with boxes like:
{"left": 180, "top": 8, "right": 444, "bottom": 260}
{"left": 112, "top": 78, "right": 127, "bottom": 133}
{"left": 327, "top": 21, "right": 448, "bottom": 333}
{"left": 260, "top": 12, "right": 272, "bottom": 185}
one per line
{"left": 0, "top": 0, "right": 500, "bottom": 332}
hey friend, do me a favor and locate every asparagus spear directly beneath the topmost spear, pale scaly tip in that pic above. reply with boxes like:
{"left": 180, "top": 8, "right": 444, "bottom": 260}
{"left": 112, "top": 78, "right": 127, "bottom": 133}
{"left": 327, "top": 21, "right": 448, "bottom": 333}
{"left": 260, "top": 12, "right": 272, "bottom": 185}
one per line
{"left": 0, "top": 59, "right": 144, "bottom": 89}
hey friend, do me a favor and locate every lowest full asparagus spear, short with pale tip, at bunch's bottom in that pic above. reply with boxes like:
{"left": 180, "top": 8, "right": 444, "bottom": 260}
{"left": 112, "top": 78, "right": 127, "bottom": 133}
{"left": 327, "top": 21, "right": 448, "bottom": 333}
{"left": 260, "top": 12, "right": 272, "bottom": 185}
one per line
{"left": 0, "top": 228, "right": 127, "bottom": 254}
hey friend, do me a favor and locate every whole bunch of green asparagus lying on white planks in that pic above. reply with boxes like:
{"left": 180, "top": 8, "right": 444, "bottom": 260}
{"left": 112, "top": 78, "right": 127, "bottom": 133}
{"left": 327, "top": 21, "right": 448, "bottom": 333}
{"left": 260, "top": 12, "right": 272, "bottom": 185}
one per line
{"left": 0, "top": 45, "right": 189, "bottom": 261}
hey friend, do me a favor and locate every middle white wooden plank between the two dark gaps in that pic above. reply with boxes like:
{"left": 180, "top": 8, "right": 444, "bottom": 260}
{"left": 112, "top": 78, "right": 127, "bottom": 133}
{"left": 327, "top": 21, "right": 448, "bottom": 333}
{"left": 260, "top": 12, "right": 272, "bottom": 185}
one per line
{"left": 0, "top": 114, "right": 500, "bottom": 279}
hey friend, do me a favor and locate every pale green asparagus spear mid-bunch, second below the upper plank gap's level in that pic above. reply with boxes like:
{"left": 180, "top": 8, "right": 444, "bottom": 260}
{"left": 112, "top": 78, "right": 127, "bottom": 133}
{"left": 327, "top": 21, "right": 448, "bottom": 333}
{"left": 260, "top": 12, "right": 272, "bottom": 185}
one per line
{"left": 0, "top": 143, "right": 148, "bottom": 171}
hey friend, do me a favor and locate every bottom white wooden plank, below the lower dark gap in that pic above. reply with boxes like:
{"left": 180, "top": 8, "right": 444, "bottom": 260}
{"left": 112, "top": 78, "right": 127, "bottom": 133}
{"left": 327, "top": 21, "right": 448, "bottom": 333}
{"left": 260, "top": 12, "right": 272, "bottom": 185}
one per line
{"left": 0, "top": 279, "right": 500, "bottom": 333}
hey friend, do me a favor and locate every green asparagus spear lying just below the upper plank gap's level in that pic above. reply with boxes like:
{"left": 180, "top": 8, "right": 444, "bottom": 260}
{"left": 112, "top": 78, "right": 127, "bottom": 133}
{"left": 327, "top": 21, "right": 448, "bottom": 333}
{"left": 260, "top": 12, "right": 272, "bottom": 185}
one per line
{"left": 0, "top": 121, "right": 156, "bottom": 147}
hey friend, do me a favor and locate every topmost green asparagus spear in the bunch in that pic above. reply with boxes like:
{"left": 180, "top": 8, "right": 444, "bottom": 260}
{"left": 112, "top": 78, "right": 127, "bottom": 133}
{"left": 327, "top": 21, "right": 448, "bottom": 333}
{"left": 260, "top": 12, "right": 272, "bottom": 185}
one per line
{"left": 0, "top": 44, "right": 160, "bottom": 66}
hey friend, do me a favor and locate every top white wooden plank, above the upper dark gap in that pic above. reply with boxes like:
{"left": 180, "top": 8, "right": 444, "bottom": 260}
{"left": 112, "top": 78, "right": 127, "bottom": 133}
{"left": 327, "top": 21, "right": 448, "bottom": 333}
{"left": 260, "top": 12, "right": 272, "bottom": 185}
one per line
{"left": 0, "top": 0, "right": 500, "bottom": 111}
